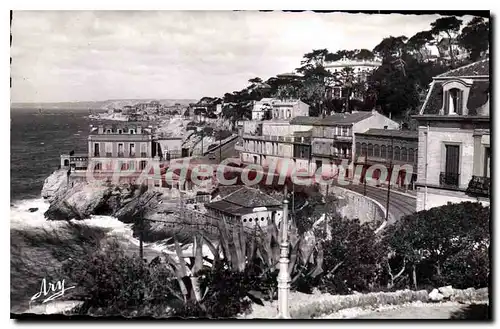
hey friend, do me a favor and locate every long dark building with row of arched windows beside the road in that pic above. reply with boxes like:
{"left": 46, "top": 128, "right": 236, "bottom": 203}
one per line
{"left": 355, "top": 129, "right": 418, "bottom": 189}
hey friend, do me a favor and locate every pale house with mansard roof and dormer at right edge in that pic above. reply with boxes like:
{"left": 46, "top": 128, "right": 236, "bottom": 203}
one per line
{"left": 415, "top": 59, "right": 491, "bottom": 211}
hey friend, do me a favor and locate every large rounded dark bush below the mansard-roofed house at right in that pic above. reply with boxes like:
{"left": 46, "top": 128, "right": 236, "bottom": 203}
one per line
{"left": 386, "top": 202, "right": 490, "bottom": 288}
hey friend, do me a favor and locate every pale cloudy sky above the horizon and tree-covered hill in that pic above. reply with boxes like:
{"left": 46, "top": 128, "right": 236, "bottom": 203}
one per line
{"left": 11, "top": 11, "right": 470, "bottom": 102}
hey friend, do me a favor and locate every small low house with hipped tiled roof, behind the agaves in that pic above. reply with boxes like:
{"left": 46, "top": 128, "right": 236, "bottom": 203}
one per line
{"left": 205, "top": 186, "right": 283, "bottom": 228}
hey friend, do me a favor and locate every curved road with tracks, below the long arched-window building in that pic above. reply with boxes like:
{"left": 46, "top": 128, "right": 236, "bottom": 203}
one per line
{"left": 342, "top": 184, "right": 417, "bottom": 224}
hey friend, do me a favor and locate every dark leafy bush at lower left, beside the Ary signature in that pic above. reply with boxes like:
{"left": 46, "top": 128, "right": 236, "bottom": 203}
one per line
{"left": 63, "top": 242, "right": 179, "bottom": 316}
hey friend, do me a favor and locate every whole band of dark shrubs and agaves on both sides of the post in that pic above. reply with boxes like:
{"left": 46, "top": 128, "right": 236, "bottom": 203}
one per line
{"left": 57, "top": 202, "right": 490, "bottom": 318}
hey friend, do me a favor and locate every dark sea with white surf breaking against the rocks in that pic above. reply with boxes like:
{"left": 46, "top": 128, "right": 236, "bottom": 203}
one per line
{"left": 10, "top": 109, "right": 161, "bottom": 313}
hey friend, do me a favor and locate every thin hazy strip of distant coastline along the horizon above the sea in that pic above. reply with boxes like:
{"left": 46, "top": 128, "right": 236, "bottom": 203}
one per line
{"left": 11, "top": 98, "right": 198, "bottom": 110}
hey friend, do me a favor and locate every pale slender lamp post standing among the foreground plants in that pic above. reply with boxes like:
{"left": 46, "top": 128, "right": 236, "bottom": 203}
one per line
{"left": 278, "top": 185, "right": 290, "bottom": 319}
